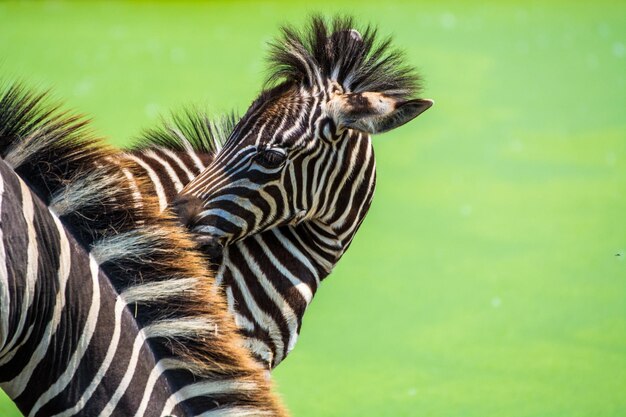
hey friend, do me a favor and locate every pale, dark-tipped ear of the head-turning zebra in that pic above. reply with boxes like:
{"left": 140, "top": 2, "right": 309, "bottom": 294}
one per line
{"left": 328, "top": 93, "right": 433, "bottom": 134}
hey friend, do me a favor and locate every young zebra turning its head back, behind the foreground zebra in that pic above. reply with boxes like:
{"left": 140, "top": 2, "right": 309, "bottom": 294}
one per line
{"left": 114, "top": 17, "right": 432, "bottom": 369}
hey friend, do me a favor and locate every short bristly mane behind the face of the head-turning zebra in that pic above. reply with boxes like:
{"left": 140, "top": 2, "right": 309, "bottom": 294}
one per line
{"left": 131, "top": 108, "right": 239, "bottom": 154}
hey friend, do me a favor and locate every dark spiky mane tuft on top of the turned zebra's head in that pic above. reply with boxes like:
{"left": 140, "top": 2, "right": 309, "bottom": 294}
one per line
{"left": 266, "top": 16, "right": 420, "bottom": 98}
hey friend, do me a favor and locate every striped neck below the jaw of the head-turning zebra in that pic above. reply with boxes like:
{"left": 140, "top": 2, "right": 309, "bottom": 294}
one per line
{"left": 215, "top": 219, "right": 345, "bottom": 369}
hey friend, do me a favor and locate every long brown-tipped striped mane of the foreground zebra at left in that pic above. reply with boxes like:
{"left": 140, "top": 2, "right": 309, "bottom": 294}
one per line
{"left": 0, "top": 85, "right": 282, "bottom": 415}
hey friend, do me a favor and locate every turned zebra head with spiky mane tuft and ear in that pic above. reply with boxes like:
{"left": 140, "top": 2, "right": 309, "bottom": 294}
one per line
{"left": 175, "top": 17, "right": 433, "bottom": 247}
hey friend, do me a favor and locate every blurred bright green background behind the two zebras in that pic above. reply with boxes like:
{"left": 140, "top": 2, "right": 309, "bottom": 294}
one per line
{"left": 0, "top": 1, "right": 626, "bottom": 417}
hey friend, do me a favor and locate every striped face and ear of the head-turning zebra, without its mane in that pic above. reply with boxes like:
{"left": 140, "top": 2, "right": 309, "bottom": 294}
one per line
{"left": 176, "top": 81, "right": 432, "bottom": 250}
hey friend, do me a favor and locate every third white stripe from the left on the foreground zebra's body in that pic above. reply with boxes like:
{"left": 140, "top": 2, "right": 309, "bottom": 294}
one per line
{"left": 0, "top": 206, "right": 72, "bottom": 398}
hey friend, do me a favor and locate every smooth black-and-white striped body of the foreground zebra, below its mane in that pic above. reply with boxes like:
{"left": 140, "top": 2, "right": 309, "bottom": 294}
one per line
{"left": 0, "top": 157, "right": 179, "bottom": 416}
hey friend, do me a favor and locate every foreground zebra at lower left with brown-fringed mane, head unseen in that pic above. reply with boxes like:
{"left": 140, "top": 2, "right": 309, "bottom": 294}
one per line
{"left": 0, "top": 84, "right": 286, "bottom": 416}
